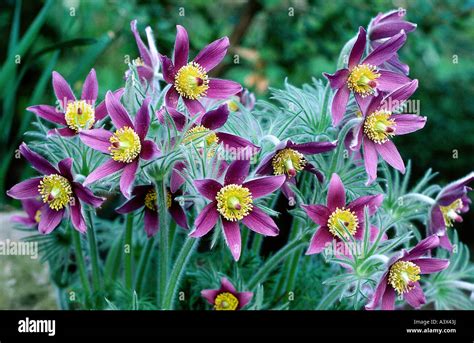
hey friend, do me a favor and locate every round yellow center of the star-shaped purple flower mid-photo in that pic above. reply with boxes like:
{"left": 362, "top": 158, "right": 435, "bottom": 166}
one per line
{"left": 216, "top": 184, "right": 253, "bottom": 221}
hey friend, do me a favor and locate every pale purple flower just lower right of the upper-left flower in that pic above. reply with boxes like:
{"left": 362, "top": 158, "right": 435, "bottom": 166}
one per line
{"left": 80, "top": 92, "right": 160, "bottom": 198}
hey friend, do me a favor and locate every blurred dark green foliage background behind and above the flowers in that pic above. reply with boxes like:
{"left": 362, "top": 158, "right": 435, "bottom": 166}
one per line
{"left": 0, "top": 0, "right": 474, "bottom": 236}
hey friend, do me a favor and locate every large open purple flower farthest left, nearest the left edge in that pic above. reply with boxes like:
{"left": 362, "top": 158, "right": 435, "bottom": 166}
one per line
{"left": 7, "top": 143, "right": 105, "bottom": 234}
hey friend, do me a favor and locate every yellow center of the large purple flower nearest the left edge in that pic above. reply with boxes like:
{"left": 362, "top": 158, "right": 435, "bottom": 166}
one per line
{"left": 35, "top": 174, "right": 72, "bottom": 211}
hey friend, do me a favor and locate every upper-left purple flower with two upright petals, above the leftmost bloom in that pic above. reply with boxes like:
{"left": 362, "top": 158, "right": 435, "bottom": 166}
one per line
{"left": 27, "top": 69, "right": 124, "bottom": 137}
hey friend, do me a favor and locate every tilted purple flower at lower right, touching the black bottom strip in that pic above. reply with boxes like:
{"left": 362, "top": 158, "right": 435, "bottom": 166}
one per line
{"left": 365, "top": 235, "right": 449, "bottom": 310}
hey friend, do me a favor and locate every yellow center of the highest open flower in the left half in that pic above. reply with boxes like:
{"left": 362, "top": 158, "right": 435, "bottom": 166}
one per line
{"left": 174, "top": 62, "right": 209, "bottom": 100}
